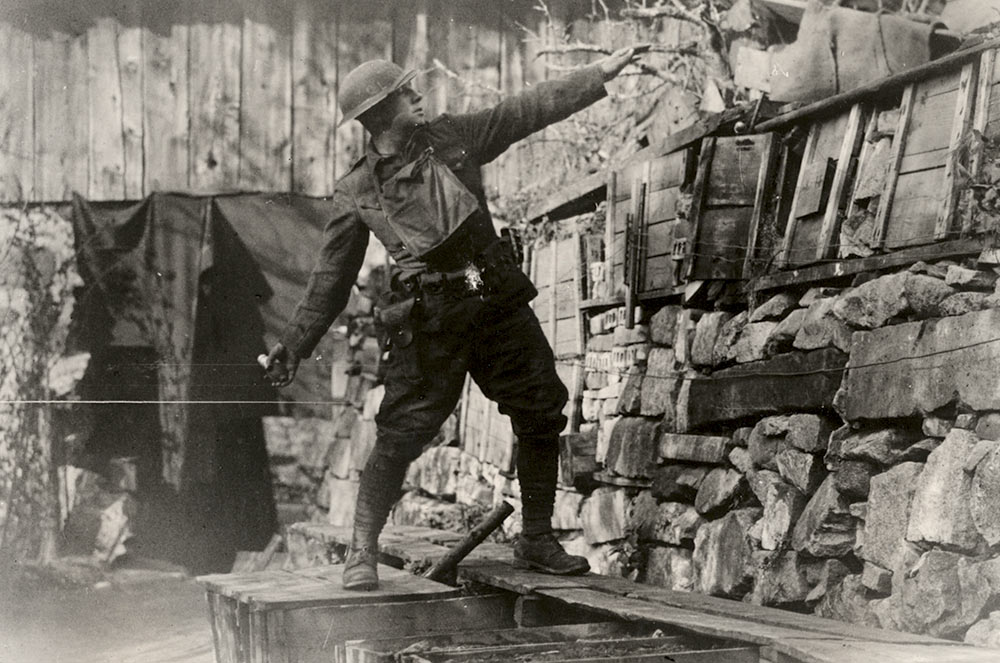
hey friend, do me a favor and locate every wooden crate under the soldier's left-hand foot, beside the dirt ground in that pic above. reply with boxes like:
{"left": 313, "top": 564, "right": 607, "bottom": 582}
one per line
{"left": 198, "top": 565, "right": 514, "bottom": 663}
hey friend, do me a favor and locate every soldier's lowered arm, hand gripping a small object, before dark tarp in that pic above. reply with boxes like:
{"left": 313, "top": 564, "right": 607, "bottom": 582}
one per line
{"left": 266, "top": 189, "right": 369, "bottom": 387}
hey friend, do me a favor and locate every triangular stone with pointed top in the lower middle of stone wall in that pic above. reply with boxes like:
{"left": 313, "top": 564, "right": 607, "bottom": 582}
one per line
{"left": 792, "top": 476, "right": 856, "bottom": 557}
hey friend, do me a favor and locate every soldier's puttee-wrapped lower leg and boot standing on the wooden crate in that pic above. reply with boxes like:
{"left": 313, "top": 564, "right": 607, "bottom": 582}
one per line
{"left": 342, "top": 452, "right": 408, "bottom": 591}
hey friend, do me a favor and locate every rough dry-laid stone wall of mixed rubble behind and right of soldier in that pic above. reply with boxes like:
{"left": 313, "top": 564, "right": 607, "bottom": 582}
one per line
{"left": 380, "top": 255, "right": 1000, "bottom": 643}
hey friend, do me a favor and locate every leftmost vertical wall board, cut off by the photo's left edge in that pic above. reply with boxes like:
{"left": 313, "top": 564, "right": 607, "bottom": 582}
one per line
{"left": 0, "top": 21, "right": 35, "bottom": 203}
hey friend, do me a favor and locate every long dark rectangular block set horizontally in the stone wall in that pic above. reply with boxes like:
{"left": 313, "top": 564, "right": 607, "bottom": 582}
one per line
{"left": 678, "top": 350, "right": 852, "bottom": 430}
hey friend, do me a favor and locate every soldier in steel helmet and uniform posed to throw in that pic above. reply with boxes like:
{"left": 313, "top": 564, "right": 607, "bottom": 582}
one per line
{"left": 266, "top": 48, "right": 636, "bottom": 590}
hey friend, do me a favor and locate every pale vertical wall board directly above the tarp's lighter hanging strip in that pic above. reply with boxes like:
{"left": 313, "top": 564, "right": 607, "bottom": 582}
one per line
{"left": 142, "top": 5, "right": 190, "bottom": 194}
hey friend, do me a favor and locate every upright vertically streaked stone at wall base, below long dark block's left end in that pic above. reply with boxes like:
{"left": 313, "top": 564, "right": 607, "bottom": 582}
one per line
{"left": 692, "top": 509, "right": 760, "bottom": 597}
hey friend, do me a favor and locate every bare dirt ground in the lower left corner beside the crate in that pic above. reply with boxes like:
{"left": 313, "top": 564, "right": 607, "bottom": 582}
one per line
{"left": 0, "top": 568, "right": 215, "bottom": 663}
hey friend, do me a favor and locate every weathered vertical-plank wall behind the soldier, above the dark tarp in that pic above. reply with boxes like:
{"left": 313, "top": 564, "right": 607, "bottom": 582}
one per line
{"left": 0, "top": 0, "right": 557, "bottom": 203}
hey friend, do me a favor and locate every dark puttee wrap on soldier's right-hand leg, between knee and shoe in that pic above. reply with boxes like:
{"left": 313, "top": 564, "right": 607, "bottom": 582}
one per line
{"left": 517, "top": 435, "right": 559, "bottom": 536}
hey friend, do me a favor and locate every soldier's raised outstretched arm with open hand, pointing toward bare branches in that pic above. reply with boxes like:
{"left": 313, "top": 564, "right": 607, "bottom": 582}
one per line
{"left": 452, "top": 48, "right": 635, "bottom": 163}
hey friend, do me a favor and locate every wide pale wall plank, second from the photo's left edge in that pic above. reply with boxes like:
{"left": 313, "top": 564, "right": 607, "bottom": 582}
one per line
{"left": 32, "top": 32, "right": 89, "bottom": 201}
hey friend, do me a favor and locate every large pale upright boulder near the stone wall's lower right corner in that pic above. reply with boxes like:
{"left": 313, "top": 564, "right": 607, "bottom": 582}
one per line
{"left": 906, "top": 429, "right": 982, "bottom": 550}
